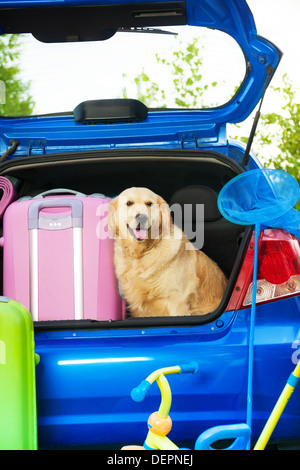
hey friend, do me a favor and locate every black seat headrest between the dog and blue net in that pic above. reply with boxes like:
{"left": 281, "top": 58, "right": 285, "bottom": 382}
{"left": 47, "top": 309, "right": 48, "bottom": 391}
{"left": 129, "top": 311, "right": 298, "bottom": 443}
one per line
{"left": 169, "top": 185, "right": 222, "bottom": 222}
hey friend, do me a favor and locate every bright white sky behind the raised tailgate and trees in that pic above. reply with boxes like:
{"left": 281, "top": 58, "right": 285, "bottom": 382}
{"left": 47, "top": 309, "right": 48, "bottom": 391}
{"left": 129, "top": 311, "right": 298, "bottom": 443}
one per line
{"left": 11, "top": 0, "right": 300, "bottom": 121}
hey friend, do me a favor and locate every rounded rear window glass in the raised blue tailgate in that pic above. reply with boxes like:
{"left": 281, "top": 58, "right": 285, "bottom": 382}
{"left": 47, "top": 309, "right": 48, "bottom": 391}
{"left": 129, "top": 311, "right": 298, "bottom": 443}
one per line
{"left": 0, "top": 26, "right": 246, "bottom": 115}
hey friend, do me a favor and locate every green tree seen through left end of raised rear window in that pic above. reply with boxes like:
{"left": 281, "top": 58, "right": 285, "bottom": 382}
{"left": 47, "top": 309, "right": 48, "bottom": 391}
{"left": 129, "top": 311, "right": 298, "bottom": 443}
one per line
{"left": 0, "top": 34, "right": 35, "bottom": 116}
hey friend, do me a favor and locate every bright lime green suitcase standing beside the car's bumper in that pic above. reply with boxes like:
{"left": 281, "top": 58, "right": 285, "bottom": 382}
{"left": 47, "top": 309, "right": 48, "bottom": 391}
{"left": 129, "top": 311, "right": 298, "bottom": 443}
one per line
{"left": 0, "top": 297, "right": 37, "bottom": 450}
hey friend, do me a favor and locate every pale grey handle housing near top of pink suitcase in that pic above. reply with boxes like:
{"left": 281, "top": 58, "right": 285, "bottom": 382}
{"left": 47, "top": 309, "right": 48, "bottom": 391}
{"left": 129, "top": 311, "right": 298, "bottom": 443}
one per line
{"left": 28, "top": 198, "right": 83, "bottom": 230}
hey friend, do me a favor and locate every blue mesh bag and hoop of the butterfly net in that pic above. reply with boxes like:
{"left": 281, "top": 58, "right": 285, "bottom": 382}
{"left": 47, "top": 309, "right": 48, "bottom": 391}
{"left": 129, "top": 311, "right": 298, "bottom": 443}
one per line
{"left": 218, "top": 168, "right": 300, "bottom": 238}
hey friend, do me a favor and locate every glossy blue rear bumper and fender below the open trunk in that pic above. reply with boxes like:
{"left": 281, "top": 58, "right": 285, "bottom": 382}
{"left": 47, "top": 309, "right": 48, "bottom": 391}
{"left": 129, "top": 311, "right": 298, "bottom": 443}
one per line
{"left": 36, "top": 297, "right": 300, "bottom": 447}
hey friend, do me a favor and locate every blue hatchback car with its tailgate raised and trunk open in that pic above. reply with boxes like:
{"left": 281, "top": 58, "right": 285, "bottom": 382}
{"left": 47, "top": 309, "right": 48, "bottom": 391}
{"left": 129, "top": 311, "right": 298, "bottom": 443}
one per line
{"left": 0, "top": 0, "right": 300, "bottom": 449}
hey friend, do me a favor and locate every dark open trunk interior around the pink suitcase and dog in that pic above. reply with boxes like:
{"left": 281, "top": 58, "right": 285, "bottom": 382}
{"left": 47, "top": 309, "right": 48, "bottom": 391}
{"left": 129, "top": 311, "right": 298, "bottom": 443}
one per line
{"left": 1, "top": 149, "right": 252, "bottom": 329}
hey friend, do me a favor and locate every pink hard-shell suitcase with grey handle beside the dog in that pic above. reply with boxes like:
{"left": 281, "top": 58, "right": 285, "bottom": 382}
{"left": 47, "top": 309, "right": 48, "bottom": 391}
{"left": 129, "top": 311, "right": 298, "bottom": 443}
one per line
{"left": 0, "top": 189, "right": 125, "bottom": 321}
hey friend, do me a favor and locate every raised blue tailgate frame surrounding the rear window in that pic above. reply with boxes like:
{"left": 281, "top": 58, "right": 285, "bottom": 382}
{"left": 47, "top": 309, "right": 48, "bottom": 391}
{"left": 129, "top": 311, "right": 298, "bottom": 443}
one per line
{"left": 0, "top": 0, "right": 281, "bottom": 155}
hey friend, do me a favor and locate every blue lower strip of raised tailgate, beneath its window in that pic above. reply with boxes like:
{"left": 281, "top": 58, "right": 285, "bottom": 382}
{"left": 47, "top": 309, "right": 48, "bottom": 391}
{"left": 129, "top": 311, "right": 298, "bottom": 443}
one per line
{"left": 0, "top": 111, "right": 226, "bottom": 159}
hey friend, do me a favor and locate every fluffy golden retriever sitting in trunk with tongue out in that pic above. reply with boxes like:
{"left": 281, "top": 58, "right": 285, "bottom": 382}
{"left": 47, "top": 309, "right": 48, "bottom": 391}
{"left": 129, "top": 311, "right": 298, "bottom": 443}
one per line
{"left": 108, "top": 188, "right": 227, "bottom": 317}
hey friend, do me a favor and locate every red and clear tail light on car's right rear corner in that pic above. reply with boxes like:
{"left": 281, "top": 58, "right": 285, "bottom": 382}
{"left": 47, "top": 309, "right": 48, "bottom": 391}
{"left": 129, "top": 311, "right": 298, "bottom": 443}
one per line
{"left": 226, "top": 229, "right": 300, "bottom": 310}
